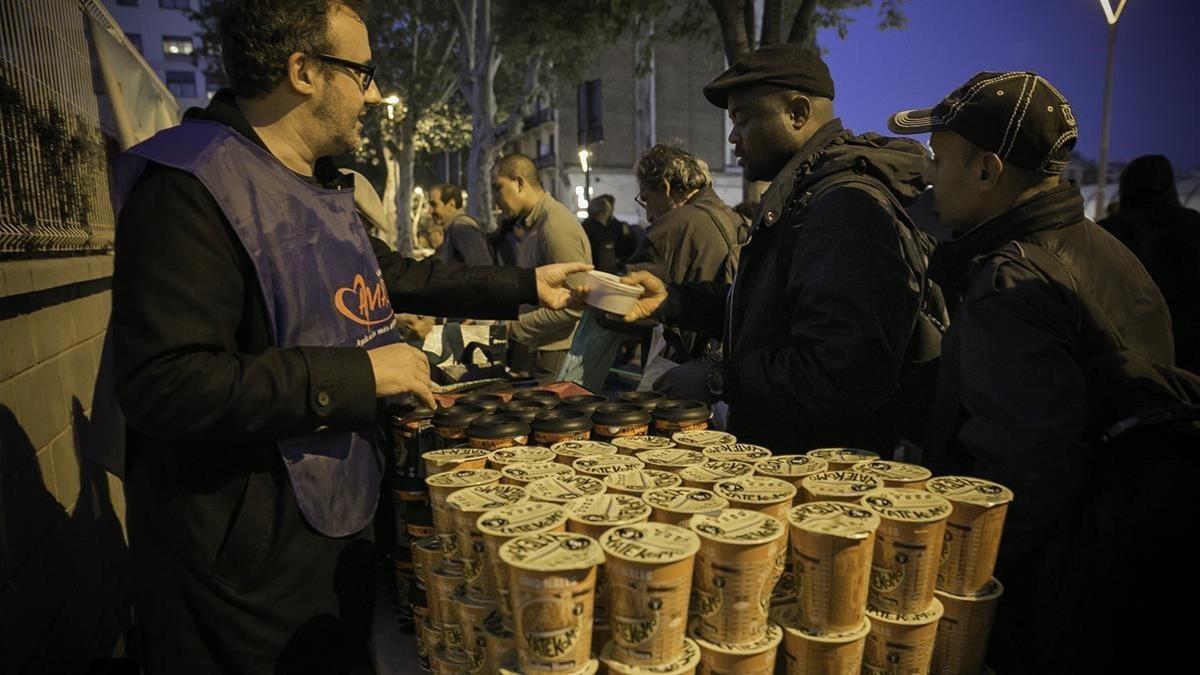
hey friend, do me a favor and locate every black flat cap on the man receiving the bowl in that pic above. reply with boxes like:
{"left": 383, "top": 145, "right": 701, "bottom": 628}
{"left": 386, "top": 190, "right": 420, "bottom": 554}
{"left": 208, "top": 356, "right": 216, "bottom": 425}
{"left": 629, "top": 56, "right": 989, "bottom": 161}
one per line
{"left": 704, "top": 43, "right": 833, "bottom": 108}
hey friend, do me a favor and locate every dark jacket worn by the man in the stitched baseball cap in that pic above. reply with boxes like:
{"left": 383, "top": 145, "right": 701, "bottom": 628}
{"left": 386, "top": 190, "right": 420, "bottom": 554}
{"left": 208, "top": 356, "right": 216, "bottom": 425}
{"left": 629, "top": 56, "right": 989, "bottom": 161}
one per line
{"left": 926, "top": 184, "right": 1174, "bottom": 673}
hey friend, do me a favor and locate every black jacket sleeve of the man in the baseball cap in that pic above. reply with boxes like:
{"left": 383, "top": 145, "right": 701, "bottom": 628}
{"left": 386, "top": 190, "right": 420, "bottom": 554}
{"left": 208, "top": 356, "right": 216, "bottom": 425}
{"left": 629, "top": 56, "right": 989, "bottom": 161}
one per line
{"left": 953, "top": 254, "right": 1093, "bottom": 563}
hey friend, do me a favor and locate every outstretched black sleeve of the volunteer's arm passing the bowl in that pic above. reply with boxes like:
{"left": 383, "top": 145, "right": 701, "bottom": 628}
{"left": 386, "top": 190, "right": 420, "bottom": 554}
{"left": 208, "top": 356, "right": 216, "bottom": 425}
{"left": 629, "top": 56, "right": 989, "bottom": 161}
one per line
{"left": 371, "top": 238, "right": 538, "bottom": 318}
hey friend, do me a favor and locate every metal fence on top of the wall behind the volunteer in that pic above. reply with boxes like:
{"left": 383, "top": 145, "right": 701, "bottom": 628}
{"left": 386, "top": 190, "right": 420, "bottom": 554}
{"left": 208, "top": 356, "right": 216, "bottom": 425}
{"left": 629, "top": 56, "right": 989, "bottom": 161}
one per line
{"left": 0, "top": 0, "right": 138, "bottom": 258}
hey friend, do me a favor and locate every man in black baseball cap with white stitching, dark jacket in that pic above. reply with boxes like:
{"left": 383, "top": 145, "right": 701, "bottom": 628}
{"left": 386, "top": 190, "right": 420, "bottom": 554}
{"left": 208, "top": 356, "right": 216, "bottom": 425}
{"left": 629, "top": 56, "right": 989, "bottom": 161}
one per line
{"left": 888, "top": 72, "right": 1174, "bottom": 673}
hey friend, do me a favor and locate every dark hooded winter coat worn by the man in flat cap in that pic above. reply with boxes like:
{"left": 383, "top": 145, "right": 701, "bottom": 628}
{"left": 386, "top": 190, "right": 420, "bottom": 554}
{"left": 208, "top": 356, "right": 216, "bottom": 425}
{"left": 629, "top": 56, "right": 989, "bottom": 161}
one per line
{"left": 664, "top": 120, "right": 940, "bottom": 454}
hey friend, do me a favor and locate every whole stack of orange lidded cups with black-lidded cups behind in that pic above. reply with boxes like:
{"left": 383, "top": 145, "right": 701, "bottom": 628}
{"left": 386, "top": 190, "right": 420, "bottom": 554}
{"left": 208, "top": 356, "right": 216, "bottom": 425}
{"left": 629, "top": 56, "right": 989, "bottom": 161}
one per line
{"left": 410, "top": 393, "right": 1013, "bottom": 675}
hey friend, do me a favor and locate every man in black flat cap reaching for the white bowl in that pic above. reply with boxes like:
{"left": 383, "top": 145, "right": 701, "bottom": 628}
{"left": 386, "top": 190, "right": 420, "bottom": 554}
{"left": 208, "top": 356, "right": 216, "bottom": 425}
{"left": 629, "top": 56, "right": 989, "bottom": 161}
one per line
{"left": 626, "top": 44, "right": 944, "bottom": 454}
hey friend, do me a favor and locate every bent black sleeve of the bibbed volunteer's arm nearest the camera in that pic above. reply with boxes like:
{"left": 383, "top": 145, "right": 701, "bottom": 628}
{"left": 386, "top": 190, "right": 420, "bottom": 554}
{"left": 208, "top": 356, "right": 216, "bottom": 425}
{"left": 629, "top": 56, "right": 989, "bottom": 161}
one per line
{"left": 112, "top": 167, "right": 377, "bottom": 441}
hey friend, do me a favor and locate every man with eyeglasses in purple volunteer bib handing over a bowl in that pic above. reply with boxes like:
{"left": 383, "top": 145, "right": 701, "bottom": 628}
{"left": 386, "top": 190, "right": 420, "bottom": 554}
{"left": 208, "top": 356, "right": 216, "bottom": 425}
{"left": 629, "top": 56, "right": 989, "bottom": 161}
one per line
{"left": 110, "top": 0, "right": 588, "bottom": 675}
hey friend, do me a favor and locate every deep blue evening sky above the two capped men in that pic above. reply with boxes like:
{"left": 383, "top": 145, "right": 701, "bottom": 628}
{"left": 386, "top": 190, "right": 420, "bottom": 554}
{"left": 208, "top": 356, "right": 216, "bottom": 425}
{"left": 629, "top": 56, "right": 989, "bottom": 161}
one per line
{"left": 820, "top": 0, "right": 1200, "bottom": 174}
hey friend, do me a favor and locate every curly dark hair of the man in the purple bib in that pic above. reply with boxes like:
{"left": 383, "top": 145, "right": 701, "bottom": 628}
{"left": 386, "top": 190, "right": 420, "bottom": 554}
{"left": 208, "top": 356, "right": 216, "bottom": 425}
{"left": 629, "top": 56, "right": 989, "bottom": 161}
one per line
{"left": 218, "top": 0, "right": 367, "bottom": 98}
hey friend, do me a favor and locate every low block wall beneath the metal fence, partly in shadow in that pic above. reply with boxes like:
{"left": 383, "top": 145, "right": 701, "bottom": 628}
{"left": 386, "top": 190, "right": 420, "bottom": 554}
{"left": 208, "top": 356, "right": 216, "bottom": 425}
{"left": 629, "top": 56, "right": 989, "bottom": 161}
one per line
{"left": 0, "top": 256, "right": 128, "bottom": 673}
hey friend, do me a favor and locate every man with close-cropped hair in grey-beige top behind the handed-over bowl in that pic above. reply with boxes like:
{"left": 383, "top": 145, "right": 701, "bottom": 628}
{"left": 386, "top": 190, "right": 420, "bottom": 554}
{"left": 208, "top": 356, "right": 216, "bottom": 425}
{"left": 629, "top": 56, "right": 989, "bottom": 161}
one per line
{"left": 492, "top": 153, "right": 592, "bottom": 372}
